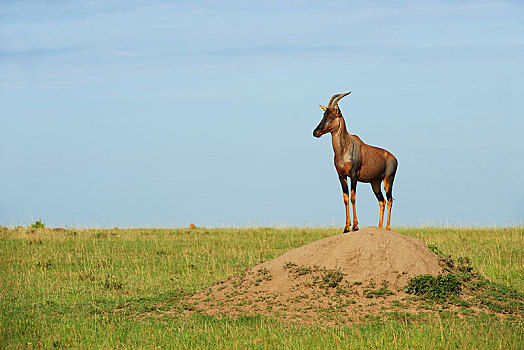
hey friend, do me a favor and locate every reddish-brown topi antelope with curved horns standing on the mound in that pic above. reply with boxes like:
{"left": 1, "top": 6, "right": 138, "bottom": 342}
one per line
{"left": 313, "top": 91, "right": 398, "bottom": 232}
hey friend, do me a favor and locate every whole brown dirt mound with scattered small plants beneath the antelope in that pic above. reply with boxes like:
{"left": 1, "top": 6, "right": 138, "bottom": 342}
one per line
{"left": 191, "top": 227, "right": 442, "bottom": 321}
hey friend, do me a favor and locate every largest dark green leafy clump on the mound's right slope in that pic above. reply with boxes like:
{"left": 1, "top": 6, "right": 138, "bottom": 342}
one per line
{"left": 405, "top": 274, "right": 461, "bottom": 300}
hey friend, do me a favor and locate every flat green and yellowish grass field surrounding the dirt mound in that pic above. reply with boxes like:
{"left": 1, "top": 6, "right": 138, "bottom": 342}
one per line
{"left": 0, "top": 227, "right": 524, "bottom": 349}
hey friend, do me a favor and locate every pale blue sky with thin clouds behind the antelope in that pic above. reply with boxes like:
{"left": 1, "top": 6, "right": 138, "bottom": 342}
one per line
{"left": 0, "top": 1, "right": 524, "bottom": 227}
